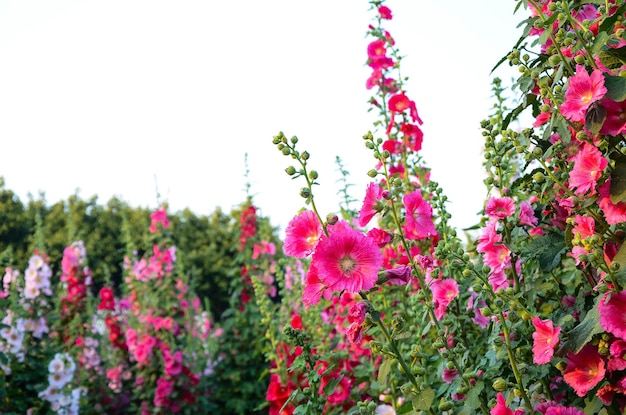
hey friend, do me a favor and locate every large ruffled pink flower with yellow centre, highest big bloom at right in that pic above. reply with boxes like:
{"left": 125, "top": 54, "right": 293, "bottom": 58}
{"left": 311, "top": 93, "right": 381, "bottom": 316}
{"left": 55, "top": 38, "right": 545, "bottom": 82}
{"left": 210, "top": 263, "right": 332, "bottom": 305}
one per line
{"left": 561, "top": 65, "right": 607, "bottom": 122}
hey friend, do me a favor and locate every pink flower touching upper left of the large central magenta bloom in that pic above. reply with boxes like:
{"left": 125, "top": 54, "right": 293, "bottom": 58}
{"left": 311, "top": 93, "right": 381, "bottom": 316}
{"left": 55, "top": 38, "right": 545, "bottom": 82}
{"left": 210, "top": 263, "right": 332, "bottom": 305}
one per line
{"left": 283, "top": 210, "right": 323, "bottom": 258}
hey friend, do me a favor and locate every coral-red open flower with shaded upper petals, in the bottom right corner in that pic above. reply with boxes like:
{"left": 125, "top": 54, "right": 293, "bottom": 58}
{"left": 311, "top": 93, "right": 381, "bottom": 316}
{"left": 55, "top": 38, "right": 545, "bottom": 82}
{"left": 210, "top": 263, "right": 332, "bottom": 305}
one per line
{"left": 563, "top": 344, "right": 606, "bottom": 398}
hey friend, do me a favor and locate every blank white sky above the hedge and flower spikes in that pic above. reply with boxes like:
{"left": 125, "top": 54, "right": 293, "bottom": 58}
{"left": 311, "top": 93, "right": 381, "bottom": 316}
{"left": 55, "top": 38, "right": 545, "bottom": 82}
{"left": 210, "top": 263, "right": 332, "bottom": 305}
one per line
{"left": 0, "top": 0, "right": 526, "bottom": 234}
